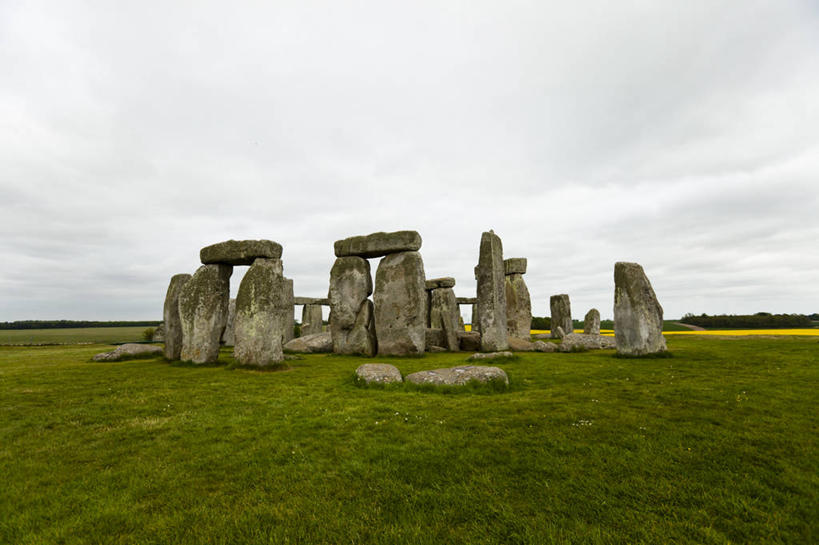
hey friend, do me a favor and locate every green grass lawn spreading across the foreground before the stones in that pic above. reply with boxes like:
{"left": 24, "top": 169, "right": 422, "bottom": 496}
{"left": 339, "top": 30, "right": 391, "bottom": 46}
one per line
{"left": 0, "top": 337, "right": 819, "bottom": 544}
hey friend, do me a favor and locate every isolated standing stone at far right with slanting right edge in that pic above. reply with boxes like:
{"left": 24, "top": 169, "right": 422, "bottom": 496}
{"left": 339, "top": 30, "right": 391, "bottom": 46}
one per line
{"left": 614, "top": 262, "right": 666, "bottom": 356}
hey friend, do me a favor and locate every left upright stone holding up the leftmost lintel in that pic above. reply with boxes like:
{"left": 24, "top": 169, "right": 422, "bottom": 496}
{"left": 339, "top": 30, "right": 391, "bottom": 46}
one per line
{"left": 179, "top": 264, "right": 233, "bottom": 363}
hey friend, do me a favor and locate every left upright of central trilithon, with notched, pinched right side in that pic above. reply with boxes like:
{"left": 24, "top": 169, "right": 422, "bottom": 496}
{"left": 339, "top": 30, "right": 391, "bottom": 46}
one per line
{"left": 328, "top": 256, "right": 377, "bottom": 356}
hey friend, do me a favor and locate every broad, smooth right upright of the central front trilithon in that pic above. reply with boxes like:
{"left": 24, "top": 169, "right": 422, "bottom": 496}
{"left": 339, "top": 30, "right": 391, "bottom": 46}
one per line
{"left": 373, "top": 252, "right": 427, "bottom": 356}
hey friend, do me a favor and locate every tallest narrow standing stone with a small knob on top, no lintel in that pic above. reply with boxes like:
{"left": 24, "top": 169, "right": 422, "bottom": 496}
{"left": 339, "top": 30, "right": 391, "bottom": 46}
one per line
{"left": 477, "top": 231, "right": 509, "bottom": 352}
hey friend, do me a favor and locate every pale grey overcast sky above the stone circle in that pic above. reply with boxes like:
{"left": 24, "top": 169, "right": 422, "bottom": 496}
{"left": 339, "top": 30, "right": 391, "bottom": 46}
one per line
{"left": 0, "top": 0, "right": 819, "bottom": 321}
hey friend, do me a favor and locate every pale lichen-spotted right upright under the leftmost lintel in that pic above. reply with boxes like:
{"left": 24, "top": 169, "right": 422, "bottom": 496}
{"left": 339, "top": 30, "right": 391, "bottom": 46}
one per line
{"left": 233, "top": 258, "right": 293, "bottom": 367}
